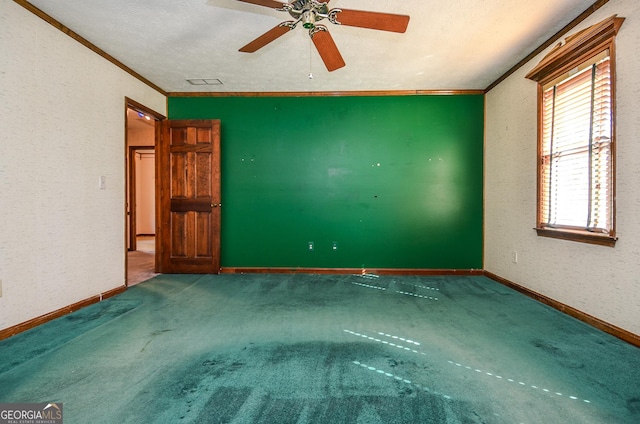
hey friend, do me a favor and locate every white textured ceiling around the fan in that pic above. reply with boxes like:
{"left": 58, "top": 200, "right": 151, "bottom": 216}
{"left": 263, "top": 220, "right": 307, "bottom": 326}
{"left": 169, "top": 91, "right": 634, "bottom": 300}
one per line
{"left": 23, "top": 0, "right": 593, "bottom": 92}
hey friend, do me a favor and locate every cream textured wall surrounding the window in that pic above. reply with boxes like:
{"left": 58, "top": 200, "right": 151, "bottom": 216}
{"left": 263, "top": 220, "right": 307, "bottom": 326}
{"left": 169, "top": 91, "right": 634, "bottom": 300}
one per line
{"left": 484, "top": 0, "right": 640, "bottom": 334}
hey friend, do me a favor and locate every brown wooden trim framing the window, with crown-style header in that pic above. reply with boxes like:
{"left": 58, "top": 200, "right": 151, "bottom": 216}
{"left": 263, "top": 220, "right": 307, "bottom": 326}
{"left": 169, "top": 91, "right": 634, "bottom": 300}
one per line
{"left": 526, "top": 15, "right": 624, "bottom": 247}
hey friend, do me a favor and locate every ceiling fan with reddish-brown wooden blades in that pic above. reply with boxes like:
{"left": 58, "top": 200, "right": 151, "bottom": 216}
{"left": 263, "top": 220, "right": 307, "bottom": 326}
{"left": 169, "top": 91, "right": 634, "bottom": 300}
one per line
{"left": 238, "top": 0, "right": 409, "bottom": 72}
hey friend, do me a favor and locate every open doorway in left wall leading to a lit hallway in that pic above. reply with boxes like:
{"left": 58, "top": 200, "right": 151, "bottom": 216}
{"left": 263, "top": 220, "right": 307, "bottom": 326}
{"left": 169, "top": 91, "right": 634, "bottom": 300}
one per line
{"left": 125, "top": 99, "right": 164, "bottom": 286}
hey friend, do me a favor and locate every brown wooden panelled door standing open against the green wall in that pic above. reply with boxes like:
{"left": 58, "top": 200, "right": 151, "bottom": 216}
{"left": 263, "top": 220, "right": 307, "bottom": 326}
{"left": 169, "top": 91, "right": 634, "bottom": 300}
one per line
{"left": 156, "top": 120, "right": 222, "bottom": 274}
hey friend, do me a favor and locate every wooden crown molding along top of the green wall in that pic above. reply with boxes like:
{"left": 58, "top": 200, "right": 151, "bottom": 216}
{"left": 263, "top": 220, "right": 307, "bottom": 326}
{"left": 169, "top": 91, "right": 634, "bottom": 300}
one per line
{"left": 167, "top": 90, "right": 484, "bottom": 97}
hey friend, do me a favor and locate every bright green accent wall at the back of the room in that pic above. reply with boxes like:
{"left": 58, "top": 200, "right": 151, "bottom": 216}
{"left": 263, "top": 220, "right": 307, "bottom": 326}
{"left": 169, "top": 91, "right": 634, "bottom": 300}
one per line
{"left": 168, "top": 95, "right": 484, "bottom": 269}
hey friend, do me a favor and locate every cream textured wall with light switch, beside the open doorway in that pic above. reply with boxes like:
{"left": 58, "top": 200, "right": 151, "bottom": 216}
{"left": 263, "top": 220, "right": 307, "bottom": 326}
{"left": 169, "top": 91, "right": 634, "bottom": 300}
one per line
{"left": 0, "top": 1, "right": 166, "bottom": 329}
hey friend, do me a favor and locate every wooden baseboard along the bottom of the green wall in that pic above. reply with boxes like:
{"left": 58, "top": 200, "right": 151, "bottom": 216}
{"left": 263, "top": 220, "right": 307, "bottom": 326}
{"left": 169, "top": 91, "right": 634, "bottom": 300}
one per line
{"left": 220, "top": 267, "right": 484, "bottom": 275}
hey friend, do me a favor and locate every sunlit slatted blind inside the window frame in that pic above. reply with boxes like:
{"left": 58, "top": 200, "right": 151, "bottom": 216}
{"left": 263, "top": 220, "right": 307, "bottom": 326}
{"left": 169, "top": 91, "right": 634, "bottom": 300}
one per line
{"left": 539, "top": 52, "right": 613, "bottom": 233}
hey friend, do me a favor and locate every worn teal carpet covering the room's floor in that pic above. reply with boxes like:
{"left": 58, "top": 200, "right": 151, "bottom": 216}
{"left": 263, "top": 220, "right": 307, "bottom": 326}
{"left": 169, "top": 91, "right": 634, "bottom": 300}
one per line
{"left": 0, "top": 274, "right": 640, "bottom": 424}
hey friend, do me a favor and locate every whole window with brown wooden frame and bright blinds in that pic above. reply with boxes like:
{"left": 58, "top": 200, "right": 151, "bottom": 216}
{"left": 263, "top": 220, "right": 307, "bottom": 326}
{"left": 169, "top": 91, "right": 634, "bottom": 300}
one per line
{"left": 527, "top": 16, "right": 624, "bottom": 246}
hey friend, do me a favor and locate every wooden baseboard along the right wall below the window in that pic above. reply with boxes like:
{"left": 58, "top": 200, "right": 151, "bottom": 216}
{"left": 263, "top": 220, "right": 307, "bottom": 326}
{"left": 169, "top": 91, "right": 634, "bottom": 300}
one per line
{"left": 484, "top": 271, "right": 640, "bottom": 347}
